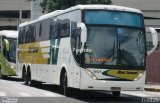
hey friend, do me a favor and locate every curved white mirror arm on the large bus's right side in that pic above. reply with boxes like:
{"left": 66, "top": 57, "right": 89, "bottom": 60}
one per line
{"left": 147, "top": 27, "right": 158, "bottom": 56}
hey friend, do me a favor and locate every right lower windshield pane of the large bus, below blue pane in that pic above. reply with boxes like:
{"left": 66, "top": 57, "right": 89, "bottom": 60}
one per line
{"left": 117, "top": 28, "right": 145, "bottom": 66}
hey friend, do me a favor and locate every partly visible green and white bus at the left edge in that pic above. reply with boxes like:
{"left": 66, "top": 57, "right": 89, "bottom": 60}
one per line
{"left": 0, "top": 30, "right": 18, "bottom": 78}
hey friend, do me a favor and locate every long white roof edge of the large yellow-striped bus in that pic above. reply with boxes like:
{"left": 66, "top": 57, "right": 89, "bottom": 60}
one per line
{"left": 19, "top": 5, "right": 142, "bottom": 27}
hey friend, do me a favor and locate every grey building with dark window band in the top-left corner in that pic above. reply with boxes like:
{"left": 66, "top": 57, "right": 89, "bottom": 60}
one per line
{"left": 0, "top": 0, "right": 31, "bottom": 30}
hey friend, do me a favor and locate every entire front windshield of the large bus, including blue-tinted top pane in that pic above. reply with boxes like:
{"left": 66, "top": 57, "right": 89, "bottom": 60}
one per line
{"left": 84, "top": 11, "right": 145, "bottom": 69}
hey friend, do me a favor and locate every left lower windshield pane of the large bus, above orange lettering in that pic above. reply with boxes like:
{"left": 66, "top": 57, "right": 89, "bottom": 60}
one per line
{"left": 85, "top": 27, "right": 117, "bottom": 65}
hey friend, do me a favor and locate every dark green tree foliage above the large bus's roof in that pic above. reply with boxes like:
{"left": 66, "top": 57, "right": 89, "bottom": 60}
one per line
{"left": 40, "top": 0, "right": 112, "bottom": 12}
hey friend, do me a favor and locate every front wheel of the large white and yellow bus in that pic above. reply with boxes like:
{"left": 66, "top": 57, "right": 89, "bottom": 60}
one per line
{"left": 61, "top": 72, "right": 69, "bottom": 96}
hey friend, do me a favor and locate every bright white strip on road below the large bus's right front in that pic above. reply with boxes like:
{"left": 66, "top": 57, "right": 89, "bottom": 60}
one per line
{"left": 122, "top": 91, "right": 150, "bottom": 97}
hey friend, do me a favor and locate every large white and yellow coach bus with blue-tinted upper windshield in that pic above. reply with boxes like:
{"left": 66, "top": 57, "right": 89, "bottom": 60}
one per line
{"left": 17, "top": 5, "right": 158, "bottom": 96}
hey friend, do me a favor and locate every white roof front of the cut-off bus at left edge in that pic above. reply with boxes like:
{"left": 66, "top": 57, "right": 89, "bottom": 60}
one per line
{"left": 0, "top": 30, "right": 18, "bottom": 38}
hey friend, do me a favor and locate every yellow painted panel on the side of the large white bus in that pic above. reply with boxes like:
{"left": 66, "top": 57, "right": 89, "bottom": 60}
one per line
{"left": 19, "top": 42, "right": 50, "bottom": 64}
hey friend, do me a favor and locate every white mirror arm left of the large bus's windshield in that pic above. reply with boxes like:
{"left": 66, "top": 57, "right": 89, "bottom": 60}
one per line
{"left": 77, "top": 23, "right": 87, "bottom": 51}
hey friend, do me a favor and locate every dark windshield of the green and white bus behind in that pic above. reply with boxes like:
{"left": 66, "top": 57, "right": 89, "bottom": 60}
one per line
{"left": 8, "top": 38, "right": 17, "bottom": 62}
